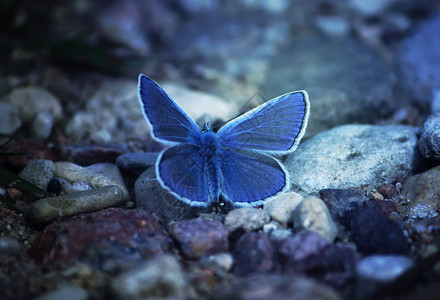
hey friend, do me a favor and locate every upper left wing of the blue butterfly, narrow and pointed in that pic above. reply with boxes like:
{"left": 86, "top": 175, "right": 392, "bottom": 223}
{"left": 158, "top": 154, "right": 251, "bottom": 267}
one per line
{"left": 139, "top": 74, "right": 200, "bottom": 143}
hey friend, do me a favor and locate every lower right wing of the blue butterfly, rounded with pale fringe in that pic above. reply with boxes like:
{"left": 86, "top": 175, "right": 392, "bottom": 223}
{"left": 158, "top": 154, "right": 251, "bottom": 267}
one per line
{"left": 220, "top": 149, "right": 289, "bottom": 206}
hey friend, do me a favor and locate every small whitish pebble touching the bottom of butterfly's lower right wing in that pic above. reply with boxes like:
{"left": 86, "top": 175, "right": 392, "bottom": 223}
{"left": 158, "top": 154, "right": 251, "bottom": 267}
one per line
{"left": 263, "top": 192, "right": 303, "bottom": 223}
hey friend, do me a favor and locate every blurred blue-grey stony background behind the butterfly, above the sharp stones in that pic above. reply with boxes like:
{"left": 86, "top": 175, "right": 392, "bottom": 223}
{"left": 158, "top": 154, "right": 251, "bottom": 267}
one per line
{"left": 0, "top": 0, "right": 440, "bottom": 151}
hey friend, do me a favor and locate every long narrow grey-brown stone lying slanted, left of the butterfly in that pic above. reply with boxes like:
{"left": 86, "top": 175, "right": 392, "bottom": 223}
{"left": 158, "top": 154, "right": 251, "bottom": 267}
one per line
{"left": 28, "top": 185, "right": 126, "bottom": 224}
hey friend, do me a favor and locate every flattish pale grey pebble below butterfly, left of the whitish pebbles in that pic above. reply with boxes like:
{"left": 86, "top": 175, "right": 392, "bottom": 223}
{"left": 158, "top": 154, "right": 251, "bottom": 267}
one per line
{"left": 225, "top": 207, "right": 270, "bottom": 232}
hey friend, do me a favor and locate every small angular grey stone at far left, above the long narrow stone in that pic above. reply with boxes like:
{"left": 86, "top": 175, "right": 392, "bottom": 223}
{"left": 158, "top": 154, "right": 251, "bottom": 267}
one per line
{"left": 18, "top": 159, "right": 55, "bottom": 190}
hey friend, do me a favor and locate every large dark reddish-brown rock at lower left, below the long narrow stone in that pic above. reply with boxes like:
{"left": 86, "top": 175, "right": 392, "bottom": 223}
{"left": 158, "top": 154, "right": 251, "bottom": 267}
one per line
{"left": 30, "top": 208, "right": 165, "bottom": 263}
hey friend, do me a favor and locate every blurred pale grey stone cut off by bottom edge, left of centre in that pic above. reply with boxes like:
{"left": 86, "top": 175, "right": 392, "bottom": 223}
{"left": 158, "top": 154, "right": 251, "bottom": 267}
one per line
{"left": 111, "top": 254, "right": 189, "bottom": 300}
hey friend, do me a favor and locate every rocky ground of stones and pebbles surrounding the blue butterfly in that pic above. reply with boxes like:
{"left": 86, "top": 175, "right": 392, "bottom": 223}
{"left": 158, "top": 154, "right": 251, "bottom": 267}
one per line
{"left": 0, "top": 0, "right": 440, "bottom": 300}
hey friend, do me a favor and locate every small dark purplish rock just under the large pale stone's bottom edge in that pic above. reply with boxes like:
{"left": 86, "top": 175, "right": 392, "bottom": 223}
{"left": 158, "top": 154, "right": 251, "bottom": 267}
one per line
{"left": 319, "top": 189, "right": 367, "bottom": 219}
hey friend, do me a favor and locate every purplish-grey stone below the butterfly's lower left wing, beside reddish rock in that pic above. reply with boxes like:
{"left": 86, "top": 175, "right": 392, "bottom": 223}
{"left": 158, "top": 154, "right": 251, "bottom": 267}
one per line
{"left": 169, "top": 220, "right": 229, "bottom": 260}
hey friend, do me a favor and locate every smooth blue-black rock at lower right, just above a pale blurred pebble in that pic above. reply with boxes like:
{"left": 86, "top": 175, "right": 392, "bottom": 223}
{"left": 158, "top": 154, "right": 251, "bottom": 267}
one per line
{"left": 348, "top": 207, "right": 408, "bottom": 254}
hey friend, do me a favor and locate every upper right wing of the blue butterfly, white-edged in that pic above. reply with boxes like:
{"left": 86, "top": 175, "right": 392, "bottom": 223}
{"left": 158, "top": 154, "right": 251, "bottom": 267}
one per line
{"left": 217, "top": 91, "right": 310, "bottom": 153}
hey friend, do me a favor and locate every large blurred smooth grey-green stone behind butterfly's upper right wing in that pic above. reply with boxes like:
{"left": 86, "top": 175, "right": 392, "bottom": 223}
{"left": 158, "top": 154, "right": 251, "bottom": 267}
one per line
{"left": 261, "top": 35, "right": 396, "bottom": 137}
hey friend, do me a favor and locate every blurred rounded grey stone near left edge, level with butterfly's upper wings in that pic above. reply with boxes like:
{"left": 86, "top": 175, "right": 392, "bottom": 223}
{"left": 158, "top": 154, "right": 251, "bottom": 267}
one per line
{"left": 5, "top": 86, "right": 63, "bottom": 122}
